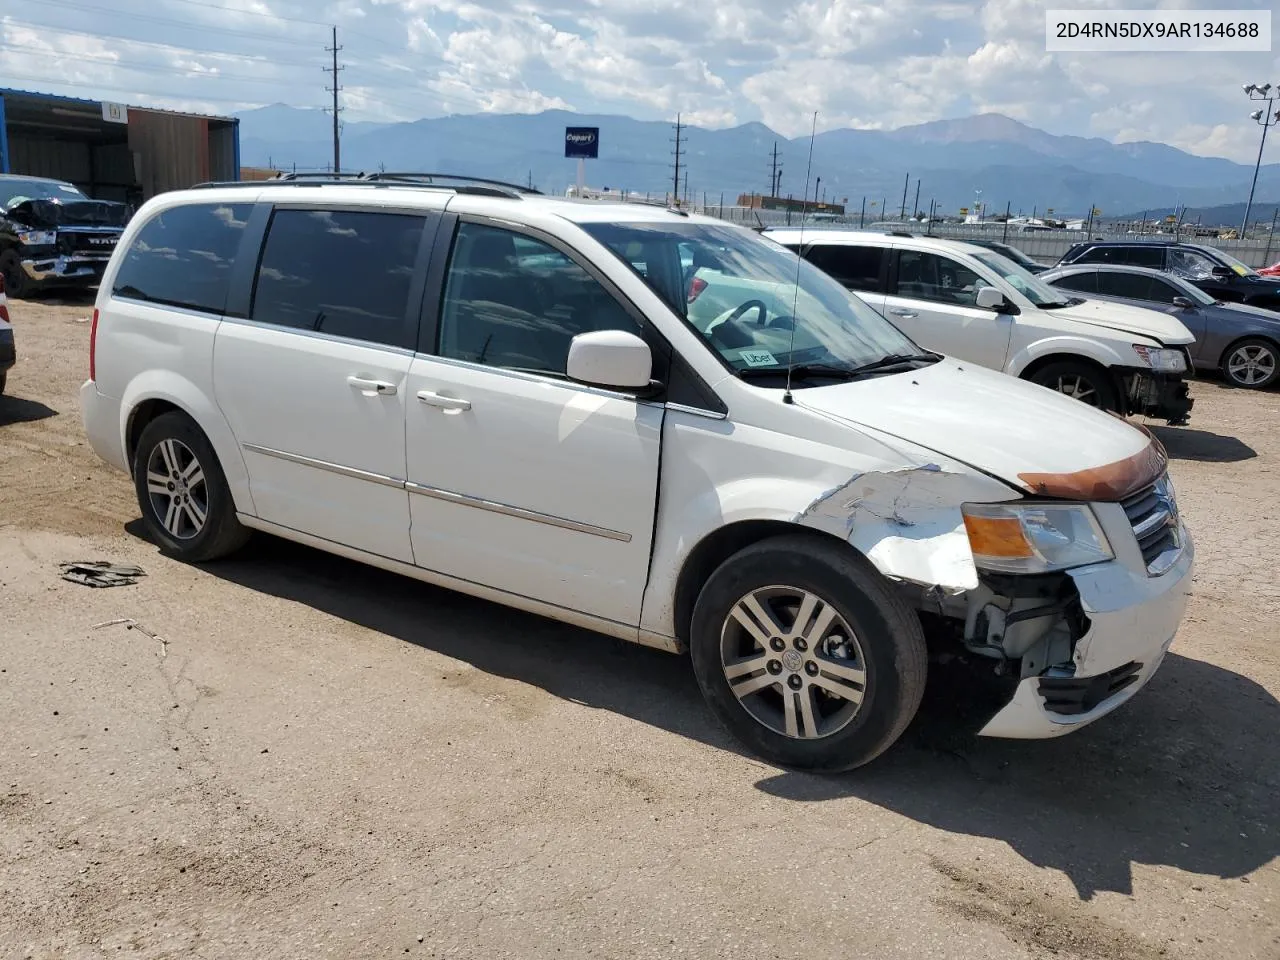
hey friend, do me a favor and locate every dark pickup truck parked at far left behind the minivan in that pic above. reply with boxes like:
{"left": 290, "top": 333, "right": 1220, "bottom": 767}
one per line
{"left": 0, "top": 175, "right": 128, "bottom": 297}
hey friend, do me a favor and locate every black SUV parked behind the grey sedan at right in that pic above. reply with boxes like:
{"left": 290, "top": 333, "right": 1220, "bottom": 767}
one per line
{"left": 1059, "top": 241, "right": 1280, "bottom": 310}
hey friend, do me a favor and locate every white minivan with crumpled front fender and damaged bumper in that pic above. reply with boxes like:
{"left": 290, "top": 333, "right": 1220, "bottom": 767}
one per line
{"left": 82, "top": 178, "right": 1193, "bottom": 769}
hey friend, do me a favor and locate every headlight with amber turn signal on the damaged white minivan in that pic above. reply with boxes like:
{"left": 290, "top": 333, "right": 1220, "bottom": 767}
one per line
{"left": 963, "top": 503, "right": 1115, "bottom": 573}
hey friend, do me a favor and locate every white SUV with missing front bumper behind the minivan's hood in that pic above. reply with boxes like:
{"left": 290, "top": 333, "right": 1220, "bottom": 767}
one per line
{"left": 765, "top": 229, "right": 1196, "bottom": 424}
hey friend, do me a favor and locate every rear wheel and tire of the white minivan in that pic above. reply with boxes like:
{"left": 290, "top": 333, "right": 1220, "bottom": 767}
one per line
{"left": 133, "top": 411, "right": 250, "bottom": 563}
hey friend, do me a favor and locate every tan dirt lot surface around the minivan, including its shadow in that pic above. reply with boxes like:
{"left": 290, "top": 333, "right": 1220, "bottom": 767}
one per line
{"left": 0, "top": 302, "right": 1280, "bottom": 960}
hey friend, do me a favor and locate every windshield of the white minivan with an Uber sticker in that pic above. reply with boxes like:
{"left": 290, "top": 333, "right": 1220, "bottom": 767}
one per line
{"left": 582, "top": 223, "right": 922, "bottom": 372}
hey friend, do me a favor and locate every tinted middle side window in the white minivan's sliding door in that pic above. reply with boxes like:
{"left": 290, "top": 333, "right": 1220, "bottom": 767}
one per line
{"left": 251, "top": 209, "right": 424, "bottom": 347}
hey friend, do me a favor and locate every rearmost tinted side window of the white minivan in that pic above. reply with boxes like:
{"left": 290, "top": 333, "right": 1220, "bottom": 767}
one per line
{"left": 111, "top": 204, "right": 253, "bottom": 314}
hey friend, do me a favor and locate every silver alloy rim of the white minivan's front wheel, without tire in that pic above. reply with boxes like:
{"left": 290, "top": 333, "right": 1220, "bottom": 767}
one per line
{"left": 721, "top": 586, "right": 867, "bottom": 740}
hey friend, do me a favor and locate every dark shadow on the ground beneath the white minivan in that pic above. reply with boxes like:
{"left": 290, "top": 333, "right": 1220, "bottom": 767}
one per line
{"left": 170, "top": 521, "right": 1280, "bottom": 899}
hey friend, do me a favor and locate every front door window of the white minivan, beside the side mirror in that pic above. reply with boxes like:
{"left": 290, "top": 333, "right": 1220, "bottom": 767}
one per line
{"left": 439, "top": 223, "right": 640, "bottom": 376}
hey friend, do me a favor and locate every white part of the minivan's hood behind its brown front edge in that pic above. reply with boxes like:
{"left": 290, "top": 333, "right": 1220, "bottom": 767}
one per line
{"left": 795, "top": 358, "right": 1151, "bottom": 489}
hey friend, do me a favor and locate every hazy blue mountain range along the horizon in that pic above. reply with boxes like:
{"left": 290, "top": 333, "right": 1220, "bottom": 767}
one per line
{"left": 239, "top": 104, "right": 1280, "bottom": 219}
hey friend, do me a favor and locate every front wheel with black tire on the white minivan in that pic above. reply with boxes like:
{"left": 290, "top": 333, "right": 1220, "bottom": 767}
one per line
{"left": 690, "top": 535, "right": 927, "bottom": 772}
